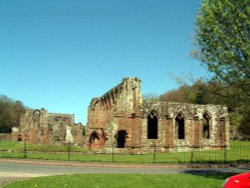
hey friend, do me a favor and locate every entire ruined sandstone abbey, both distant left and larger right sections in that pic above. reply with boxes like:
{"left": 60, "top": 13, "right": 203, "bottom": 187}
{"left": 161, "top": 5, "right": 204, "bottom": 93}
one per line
{"left": 9, "top": 78, "right": 229, "bottom": 153}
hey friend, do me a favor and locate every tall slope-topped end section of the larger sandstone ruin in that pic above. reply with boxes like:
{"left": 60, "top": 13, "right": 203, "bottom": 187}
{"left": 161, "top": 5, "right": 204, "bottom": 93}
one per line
{"left": 86, "top": 78, "right": 143, "bottom": 148}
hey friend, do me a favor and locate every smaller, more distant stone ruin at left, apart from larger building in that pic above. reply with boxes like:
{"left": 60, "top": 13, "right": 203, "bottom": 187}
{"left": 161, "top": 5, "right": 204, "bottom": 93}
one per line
{"left": 12, "top": 109, "right": 84, "bottom": 145}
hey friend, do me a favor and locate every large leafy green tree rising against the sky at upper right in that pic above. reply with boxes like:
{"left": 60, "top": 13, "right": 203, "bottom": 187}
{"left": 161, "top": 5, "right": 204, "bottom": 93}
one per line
{"left": 193, "top": 0, "right": 250, "bottom": 105}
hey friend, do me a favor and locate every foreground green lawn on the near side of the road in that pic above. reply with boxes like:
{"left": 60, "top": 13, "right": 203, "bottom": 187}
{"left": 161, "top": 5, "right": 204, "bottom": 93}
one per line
{"left": 4, "top": 174, "right": 229, "bottom": 188}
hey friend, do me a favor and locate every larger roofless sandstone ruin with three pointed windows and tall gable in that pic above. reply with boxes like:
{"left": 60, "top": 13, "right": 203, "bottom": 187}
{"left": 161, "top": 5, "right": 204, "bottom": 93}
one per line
{"left": 85, "top": 78, "right": 229, "bottom": 153}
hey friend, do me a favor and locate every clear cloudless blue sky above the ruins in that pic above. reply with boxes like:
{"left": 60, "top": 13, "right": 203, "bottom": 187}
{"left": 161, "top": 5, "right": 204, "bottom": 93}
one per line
{"left": 0, "top": 0, "right": 206, "bottom": 124}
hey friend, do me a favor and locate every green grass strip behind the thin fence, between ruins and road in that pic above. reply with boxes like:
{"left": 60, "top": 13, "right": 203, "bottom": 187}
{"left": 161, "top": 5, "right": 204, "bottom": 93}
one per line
{"left": 0, "top": 140, "right": 250, "bottom": 163}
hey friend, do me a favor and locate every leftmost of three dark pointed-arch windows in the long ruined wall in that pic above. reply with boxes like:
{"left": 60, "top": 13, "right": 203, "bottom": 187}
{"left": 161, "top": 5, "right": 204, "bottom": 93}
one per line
{"left": 148, "top": 111, "right": 158, "bottom": 139}
